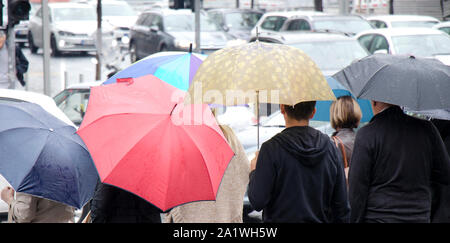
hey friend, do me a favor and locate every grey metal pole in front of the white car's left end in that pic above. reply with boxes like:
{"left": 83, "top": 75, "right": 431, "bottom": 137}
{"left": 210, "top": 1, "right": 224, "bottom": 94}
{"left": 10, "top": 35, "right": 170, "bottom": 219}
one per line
{"left": 42, "top": 0, "right": 51, "bottom": 96}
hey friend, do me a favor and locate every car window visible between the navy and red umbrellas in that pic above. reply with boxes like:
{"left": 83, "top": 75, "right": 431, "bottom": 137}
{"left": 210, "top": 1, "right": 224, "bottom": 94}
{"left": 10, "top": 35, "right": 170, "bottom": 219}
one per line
{"left": 55, "top": 89, "right": 90, "bottom": 126}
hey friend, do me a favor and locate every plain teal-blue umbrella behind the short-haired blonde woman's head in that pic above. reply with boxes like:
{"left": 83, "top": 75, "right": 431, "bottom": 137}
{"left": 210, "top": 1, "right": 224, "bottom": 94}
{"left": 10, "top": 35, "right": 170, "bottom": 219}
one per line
{"left": 312, "top": 77, "right": 373, "bottom": 123}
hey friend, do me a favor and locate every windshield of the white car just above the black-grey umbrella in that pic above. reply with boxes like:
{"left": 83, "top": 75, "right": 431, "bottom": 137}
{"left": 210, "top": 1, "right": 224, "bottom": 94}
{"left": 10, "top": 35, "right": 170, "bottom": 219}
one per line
{"left": 392, "top": 34, "right": 450, "bottom": 57}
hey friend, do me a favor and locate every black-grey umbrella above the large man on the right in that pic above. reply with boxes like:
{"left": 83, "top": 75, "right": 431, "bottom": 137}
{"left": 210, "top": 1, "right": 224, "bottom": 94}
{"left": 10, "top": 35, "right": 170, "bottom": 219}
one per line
{"left": 333, "top": 54, "right": 450, "bottom": 111}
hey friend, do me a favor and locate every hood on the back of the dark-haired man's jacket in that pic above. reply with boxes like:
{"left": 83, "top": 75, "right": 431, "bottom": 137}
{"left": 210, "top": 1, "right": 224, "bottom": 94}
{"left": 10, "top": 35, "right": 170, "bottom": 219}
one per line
{"left": 273, "top": 126, "right": 330, "bottom": 166}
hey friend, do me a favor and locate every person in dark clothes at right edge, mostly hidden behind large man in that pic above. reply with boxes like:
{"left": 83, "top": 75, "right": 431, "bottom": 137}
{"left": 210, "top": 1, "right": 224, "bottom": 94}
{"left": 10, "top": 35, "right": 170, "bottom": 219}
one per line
{"left": 431, "top": 119, "right": 450, "bottom": 223}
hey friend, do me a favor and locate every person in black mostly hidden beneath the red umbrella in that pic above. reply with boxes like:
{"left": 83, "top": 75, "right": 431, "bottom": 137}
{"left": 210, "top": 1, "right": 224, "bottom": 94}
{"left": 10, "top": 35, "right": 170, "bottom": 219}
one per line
{"left": 91, "top": 183, "right": 162, "bottom": 223}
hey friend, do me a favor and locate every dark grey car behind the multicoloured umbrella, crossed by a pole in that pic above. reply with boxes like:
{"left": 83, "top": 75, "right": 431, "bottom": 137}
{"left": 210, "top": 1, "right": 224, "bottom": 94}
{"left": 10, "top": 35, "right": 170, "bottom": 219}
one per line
{"left": 130, "top": 9, "right": 235, "bottom": 62}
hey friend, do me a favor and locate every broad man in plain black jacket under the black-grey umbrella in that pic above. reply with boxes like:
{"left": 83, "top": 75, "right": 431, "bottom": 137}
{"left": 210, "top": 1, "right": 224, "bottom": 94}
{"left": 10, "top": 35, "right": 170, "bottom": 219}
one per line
{"left": 349, "top": 101, "right": 450, "bottom": 223}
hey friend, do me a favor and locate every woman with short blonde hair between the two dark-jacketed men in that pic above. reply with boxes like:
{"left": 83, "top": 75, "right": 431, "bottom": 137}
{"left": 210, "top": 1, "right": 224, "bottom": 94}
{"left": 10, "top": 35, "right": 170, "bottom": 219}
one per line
{"left": 330, "top": 96, "right": 362, "bottom": 178}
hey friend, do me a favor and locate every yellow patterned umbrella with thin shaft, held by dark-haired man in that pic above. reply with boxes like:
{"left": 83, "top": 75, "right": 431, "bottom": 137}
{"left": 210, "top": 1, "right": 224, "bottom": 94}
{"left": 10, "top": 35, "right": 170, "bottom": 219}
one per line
{"left": 186, "top": 41, "right": 336, "bottom": 146}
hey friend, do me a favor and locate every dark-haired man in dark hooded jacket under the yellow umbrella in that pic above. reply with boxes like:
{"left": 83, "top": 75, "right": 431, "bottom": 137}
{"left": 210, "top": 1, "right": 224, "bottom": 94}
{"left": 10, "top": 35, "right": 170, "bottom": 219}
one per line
{"left": 248, "top": 101, "right": 350, "bottom": 223}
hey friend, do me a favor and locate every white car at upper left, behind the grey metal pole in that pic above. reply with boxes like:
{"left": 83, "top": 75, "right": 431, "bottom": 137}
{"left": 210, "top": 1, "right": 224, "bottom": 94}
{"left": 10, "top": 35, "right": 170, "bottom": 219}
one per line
{"left": 28, "top": 2, "right": 113, "bottom": 56}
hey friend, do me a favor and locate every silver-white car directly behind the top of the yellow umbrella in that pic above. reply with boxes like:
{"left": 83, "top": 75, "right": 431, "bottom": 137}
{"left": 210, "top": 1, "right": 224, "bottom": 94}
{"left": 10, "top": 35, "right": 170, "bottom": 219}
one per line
{"left": 252, "top": 31, "right": 369, "bottom": 76}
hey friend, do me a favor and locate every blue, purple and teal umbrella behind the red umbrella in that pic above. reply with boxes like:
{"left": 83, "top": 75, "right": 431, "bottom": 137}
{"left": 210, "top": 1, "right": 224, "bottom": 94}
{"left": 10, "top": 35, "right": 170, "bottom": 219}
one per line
{"left": 103, "top": 52, "right": 206, "bottom": 91}
